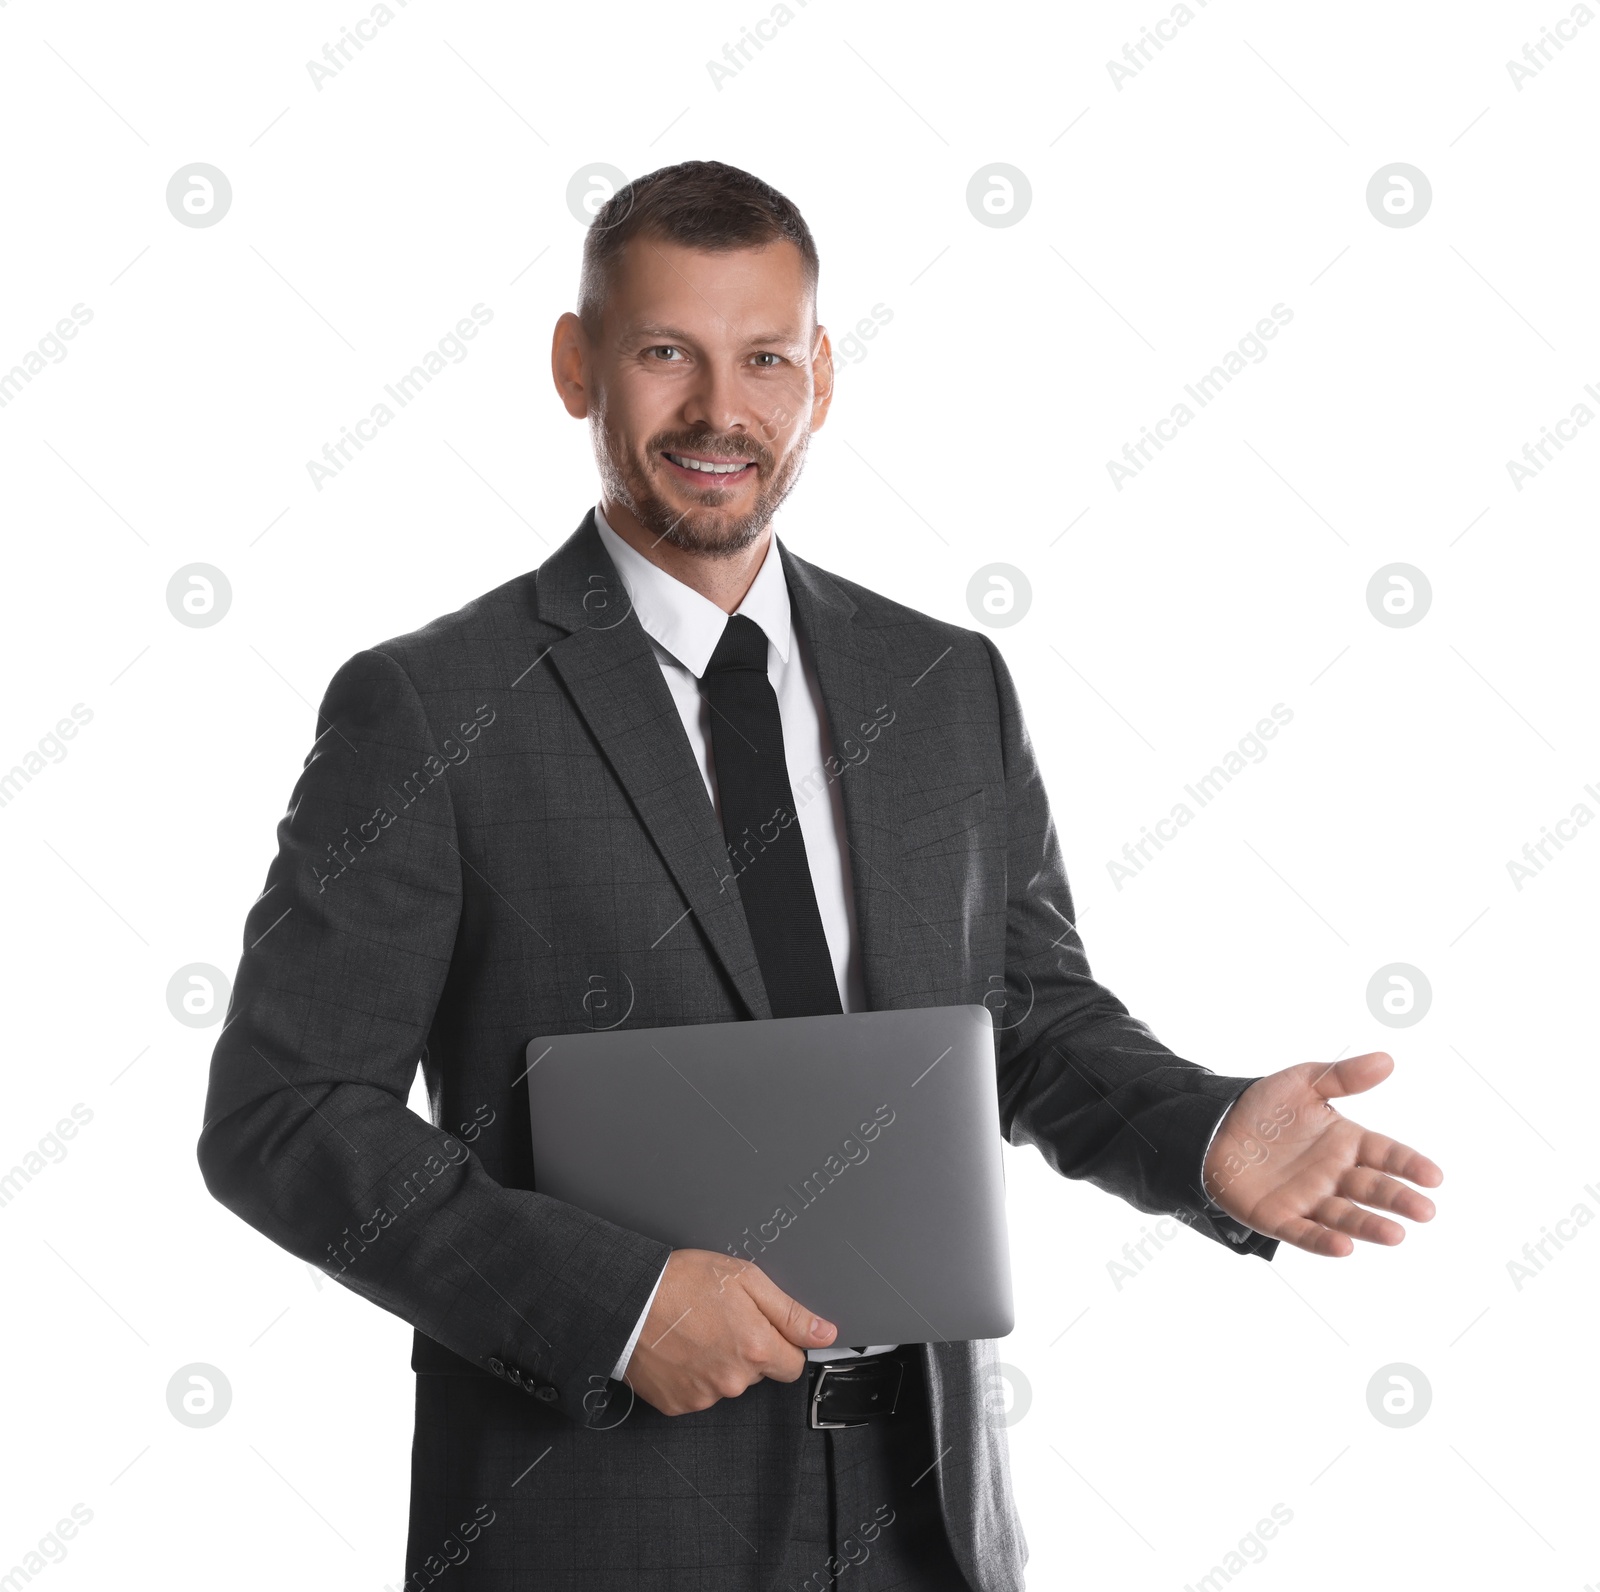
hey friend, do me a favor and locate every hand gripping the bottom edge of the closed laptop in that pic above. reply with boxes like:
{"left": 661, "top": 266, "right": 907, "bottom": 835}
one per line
{"left": 622, "top": 1250, "right": 838, "bottom": 1414}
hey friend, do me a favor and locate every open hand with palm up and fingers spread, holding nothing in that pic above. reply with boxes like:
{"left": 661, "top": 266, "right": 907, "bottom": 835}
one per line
{"left": 1205, "top": 1050, "right": 1445, "bottom": 1256}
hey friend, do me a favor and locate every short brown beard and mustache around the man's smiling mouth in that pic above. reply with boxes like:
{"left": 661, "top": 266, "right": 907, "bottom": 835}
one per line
{"left": 595, "top": 421, "right": 811, "bottom": 558}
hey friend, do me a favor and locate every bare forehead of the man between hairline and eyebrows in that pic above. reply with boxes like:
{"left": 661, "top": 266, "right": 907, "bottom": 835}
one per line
{"left": 605, "top": 234, "right": 813, "bottom": 341}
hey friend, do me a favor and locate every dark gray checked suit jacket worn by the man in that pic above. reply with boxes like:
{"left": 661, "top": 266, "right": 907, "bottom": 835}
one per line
{"left": 200, "top": 514, "right": 1275, "bottom": 1592}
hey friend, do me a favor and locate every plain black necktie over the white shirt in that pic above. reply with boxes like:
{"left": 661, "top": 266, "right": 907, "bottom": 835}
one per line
{"left": 701, "top": 614, "right": 843, "bottom": 1018}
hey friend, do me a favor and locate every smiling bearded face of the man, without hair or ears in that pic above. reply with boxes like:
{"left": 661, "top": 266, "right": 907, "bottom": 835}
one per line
{"left": 587, "top": 235, "right": 832, "bottom": 557}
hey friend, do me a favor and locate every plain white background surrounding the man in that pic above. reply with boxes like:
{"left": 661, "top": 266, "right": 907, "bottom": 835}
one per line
{"left": 0, "top": 0, "right": 1600, "bottom": 1592}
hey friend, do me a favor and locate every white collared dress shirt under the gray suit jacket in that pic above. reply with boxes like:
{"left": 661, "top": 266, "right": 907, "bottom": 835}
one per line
{"left": 595, "top": 504, "right": 894, "bottom": 1381}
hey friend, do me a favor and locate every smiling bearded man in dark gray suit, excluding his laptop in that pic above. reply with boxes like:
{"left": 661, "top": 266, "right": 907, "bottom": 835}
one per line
{"left": 200, "top": 162, "right": 1442, "bottom": 1592}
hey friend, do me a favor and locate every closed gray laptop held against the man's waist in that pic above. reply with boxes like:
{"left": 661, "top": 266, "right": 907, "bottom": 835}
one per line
{"left": 526, "top": 1005, "right": 1013, "bottom": 1344}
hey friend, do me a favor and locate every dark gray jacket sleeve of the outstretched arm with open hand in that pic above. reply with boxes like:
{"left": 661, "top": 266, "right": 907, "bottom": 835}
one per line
{"left": 979, "top": 635, "right": 1278, "bottom": 1261}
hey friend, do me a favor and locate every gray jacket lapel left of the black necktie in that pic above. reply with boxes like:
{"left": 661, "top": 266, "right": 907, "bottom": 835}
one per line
{"left": 536, "top": 509, "right": 771, "bottom": 1018}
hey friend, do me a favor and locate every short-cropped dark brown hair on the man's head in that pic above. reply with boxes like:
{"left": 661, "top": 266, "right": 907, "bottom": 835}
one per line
{"left": 578, "top": 160, "right": 818, "bottom": 336}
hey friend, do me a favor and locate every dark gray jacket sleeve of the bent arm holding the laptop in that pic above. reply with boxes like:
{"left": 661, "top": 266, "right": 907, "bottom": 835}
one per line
{"left": 198, "top": 651, "right": 670, "bottom": 1424}
